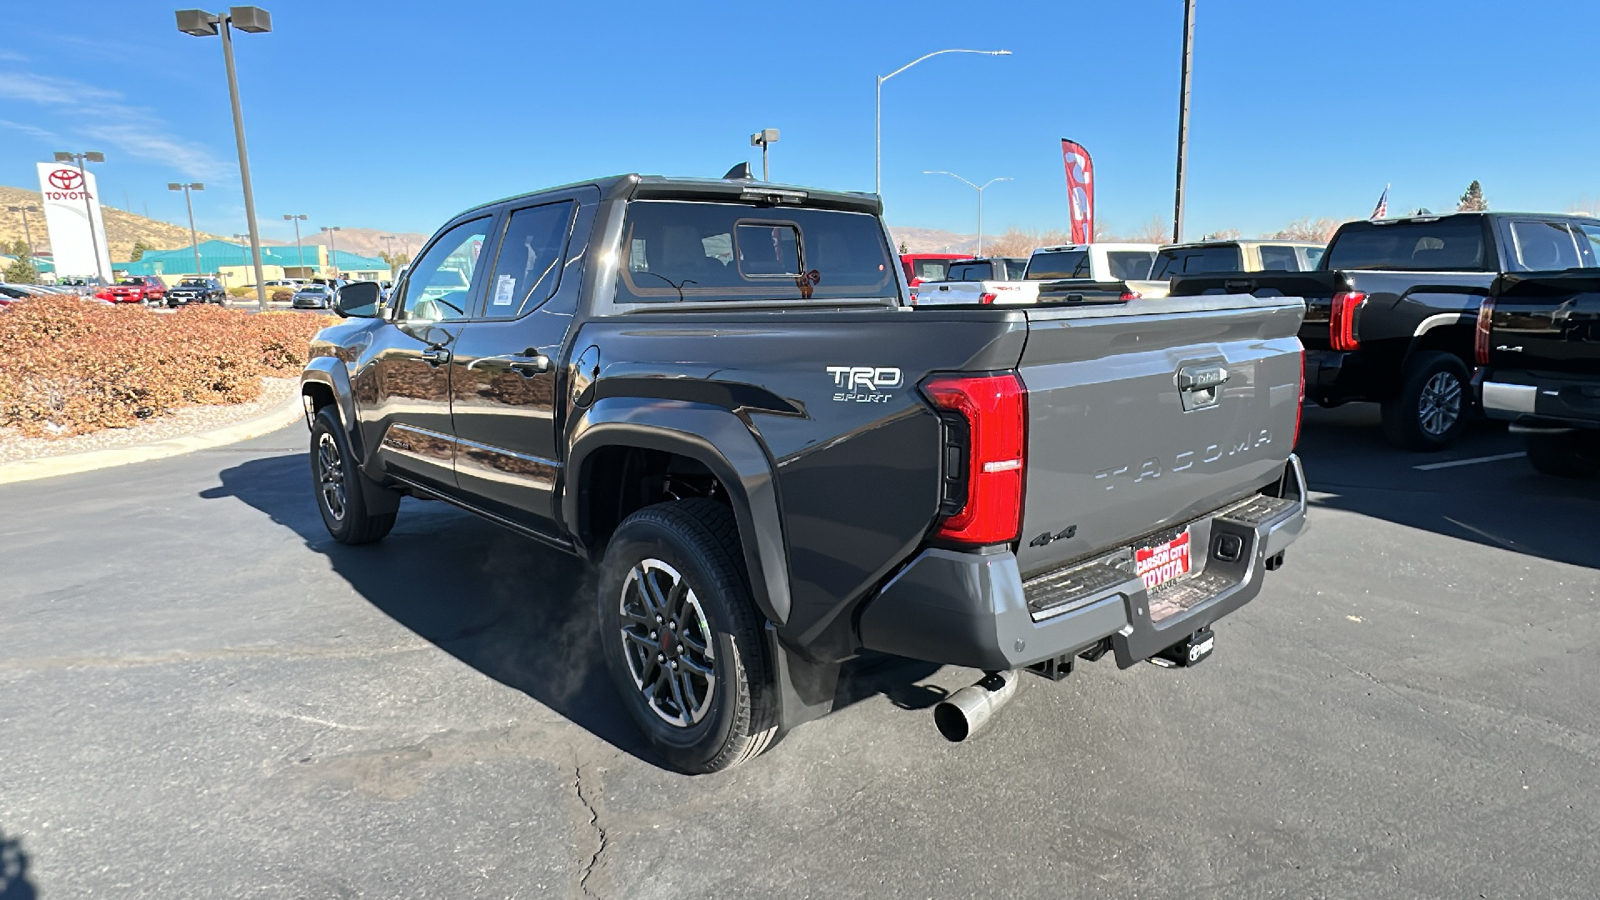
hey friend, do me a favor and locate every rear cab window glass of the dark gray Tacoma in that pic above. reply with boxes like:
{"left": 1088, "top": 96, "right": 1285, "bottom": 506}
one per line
{"left": 616, "top": 200, "right": 896, "bottom": 303}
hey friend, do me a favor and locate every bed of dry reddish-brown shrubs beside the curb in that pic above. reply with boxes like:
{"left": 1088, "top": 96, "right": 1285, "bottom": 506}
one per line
{"left": 0, "top": 296, "right": 326, "bottom": 437}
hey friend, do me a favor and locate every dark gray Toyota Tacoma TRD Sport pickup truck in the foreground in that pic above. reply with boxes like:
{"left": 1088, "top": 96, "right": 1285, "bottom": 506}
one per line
{"left": 302, "top": 175, "right": 1306, "bottom": 772}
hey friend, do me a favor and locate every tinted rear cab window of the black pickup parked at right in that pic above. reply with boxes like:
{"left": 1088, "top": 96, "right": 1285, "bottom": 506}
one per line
{"left": 1323, "top": 216, "right": 1485, "bottom": 272}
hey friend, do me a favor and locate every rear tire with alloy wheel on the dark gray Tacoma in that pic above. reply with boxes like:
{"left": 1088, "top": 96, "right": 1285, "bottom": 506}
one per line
{"left": 597, "top": 500, "right": 778, "bottom": 775}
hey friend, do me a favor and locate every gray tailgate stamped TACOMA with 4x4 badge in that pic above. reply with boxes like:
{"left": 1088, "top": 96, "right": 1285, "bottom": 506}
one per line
{"left": 1018, "top": 295, "right": 1304, "bottom": 575}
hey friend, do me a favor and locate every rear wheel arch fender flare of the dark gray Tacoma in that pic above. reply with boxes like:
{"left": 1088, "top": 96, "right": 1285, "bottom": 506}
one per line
{"left": 562, "top": 397, "right": 790, "bottom": 628}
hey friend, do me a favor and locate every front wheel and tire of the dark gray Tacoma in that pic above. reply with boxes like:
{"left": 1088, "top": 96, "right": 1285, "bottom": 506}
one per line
{"left": 310, "top": 407, "right": 400, "bottom": 544}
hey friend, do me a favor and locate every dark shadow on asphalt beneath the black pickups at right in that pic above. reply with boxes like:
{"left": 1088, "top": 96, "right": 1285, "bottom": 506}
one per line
{"left": 1296, "top": 404, "right": 1600, "bottom": 569}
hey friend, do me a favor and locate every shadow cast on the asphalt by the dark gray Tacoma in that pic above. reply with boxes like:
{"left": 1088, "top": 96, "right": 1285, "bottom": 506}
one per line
{"left": 204, "top": 453, "right": 942, "bottom": 768}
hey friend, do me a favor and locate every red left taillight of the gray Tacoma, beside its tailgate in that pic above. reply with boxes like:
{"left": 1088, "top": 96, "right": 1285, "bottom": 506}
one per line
{"left": 923, "top": 373, "right": 1027, "bottom": 544}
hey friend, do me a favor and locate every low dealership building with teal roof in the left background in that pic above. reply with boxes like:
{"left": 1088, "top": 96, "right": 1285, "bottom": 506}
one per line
{"left": 110, "top": 240, "right": 390, "bottom": 288}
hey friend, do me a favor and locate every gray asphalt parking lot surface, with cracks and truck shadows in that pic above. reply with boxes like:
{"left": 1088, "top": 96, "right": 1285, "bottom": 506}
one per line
{"left": 0, "top": 405, "right": 1600, "bottom": 900}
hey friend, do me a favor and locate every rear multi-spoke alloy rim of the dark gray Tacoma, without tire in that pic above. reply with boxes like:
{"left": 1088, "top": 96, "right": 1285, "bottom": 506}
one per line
{"left": 619, "top": 559, "right": 717, "bottom": 729}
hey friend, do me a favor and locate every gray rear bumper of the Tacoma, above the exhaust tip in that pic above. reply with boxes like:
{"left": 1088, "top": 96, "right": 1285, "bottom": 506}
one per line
{"left": 861, "top": 456, "right": 1306, "bottom": 669}
